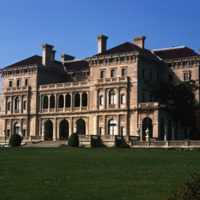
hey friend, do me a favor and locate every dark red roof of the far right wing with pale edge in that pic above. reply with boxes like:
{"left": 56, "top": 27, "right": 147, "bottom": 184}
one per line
{"left": 152, "top": 46, "right": 199, "bottom": 60}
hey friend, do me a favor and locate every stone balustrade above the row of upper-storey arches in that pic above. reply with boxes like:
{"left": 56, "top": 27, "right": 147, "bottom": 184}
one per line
{"left": 39, "top": 81, "right": 89, "bottom": 91}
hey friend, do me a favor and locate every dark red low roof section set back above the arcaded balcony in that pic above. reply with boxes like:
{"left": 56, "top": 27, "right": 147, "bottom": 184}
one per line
{"left": 64, "top": 60, "right": 89, "bottom": 71}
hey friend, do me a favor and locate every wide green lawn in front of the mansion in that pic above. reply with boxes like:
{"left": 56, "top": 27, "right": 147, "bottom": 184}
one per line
{"left": 0, "top": 148, "right": 200, "bottom": 200}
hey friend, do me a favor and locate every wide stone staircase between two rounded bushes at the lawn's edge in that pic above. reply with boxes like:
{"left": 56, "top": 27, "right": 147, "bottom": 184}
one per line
{"left": 23, "top": 140, "right": 68, "bottom": 147}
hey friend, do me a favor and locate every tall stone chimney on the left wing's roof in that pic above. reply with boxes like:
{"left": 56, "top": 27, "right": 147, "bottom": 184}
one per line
{"left": 42, "top": 44, "right": 55, "bottom": 67}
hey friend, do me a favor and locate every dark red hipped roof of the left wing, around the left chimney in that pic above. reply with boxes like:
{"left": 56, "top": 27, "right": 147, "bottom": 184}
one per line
{"left": 4, "top": 55, "right": 64, "bottom": 71}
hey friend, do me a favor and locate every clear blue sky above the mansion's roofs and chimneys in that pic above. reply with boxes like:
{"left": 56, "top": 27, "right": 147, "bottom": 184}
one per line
{"left": 0, "top": 0, "right": 200, "bottom": 86}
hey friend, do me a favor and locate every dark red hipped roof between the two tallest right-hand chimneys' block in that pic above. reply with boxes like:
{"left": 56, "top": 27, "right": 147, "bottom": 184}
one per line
{"left": 93, "top": 42, "right": 158, "bottom": 60}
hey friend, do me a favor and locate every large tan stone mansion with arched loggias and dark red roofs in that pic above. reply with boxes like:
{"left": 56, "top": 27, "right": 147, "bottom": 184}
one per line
{"left": 0, "top": 35, "right": 200, "bottom": 141}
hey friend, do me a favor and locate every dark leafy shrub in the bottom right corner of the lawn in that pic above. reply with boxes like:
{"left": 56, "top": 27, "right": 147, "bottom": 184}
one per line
{"left": 167, "top": 173, "right": 200, "bottom": 200}
